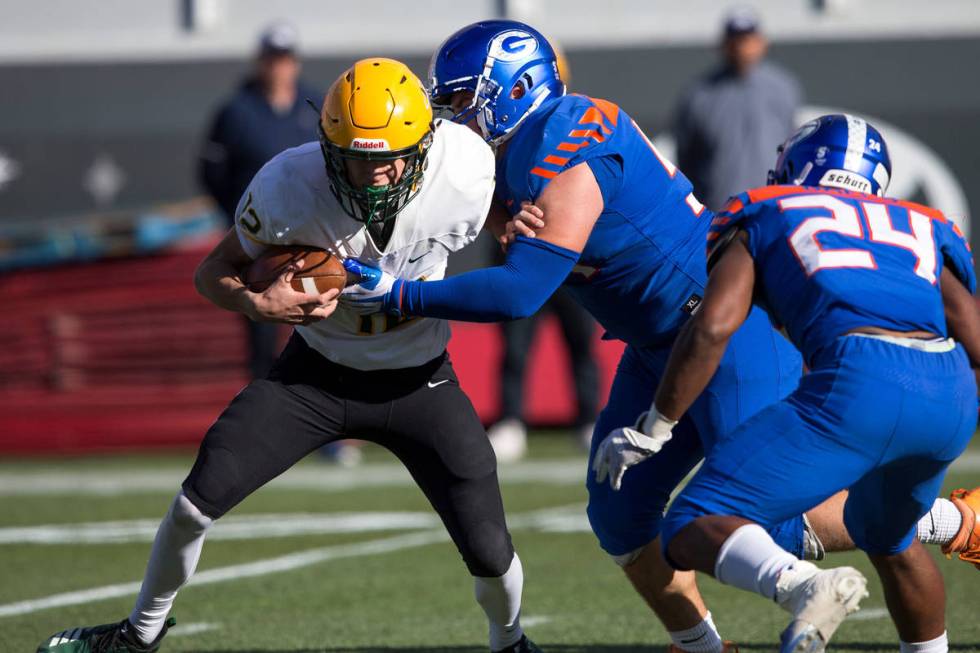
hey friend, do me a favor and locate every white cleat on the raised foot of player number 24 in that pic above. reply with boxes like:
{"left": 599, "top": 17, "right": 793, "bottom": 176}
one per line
{"left": 776, "top": 562, "right": 868, "bottom": 653}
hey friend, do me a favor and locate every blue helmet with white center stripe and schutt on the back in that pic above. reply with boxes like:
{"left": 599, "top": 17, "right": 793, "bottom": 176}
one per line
{"left": 769, "top": 114, "right": 892, "bottom": 197}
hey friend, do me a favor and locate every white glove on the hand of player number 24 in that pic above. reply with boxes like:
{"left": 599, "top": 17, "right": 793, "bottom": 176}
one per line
{"left": 592, "top": 407, "right": 677, "bottom": 490}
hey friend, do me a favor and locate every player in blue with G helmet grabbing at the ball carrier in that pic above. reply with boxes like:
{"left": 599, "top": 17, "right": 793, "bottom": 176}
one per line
{"left": 342, "top": 21, "right": 973, "bottom": 653}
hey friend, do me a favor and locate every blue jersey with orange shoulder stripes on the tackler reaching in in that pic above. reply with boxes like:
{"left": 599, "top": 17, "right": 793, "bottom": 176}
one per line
{"left": 496, "top": 95, "right": 711, "bottom": 346}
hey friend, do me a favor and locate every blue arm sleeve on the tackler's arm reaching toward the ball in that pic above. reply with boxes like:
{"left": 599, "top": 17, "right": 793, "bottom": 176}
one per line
{"left": 400, "top": 236, "right": 579, "bottom": 322}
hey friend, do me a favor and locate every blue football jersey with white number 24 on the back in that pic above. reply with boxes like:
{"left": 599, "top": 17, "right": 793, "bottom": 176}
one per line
{"left": 708, "top": 186, "right": 976, "bottom": 361}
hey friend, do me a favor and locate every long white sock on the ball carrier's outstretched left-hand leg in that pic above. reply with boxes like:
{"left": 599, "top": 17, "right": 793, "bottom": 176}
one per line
{"left": 129, "top": 492, "right": 213, "bottom": 644}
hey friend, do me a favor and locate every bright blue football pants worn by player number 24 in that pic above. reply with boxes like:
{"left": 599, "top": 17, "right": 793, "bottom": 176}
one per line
{"left": 662, "top": 336, "right": 977, "bottom": 555}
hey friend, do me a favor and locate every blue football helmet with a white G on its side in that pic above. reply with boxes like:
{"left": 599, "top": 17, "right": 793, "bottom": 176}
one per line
{"left": 429, "top": 20, "right": 565, "bottom": 145}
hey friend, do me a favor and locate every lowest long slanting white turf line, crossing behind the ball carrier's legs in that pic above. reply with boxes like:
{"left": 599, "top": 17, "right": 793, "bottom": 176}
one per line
{"left": 0, "top": 504, "right": 582, "bottom": 617}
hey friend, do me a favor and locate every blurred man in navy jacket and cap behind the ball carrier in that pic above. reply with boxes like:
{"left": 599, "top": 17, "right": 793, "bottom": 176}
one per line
{"left": 199, "top": 23, "right": 322, "bottom": 378}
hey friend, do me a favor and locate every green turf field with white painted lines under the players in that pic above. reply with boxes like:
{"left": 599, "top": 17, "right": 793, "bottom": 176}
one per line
{"left": 0, "top": 437, "right": 980, "bottom": 653}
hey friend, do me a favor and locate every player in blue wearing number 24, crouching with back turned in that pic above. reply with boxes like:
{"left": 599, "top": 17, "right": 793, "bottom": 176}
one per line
{"left": 648, "top": 115, "right": 980, "bottom": 653}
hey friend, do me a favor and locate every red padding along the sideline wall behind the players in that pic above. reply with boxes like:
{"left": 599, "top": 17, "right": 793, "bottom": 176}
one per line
{"left": 0, "top": 245, "right": 622, "bottom": 454}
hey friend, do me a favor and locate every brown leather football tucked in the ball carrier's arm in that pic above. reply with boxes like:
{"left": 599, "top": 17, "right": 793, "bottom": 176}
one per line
{"left": 243, "top": 245, "right": 347, "bottom": 294}
